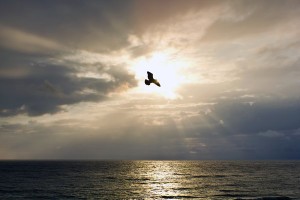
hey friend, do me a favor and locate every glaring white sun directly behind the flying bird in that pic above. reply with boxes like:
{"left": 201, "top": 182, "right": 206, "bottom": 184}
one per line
{"left": 133, "top": 51, "right": 187, "bottom": 99}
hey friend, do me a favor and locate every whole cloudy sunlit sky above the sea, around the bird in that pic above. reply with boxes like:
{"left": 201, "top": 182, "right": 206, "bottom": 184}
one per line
{"left": 0, "top": 0, "right": 300, "bottom": 160}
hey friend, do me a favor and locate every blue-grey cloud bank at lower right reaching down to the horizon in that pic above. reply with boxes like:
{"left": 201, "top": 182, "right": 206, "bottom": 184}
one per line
{"left": 170, "top": 100, "right": 300, "bottom": 159}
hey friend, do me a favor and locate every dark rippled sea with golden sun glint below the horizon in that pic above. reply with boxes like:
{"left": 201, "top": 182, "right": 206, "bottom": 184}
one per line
{"left": 0, "top": 161, "right": 300, "bottom": 199}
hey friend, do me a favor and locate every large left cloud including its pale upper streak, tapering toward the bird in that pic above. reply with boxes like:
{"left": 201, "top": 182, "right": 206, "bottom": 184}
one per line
{"left": 0, "top": 13, "right": 136, "bottom": 117}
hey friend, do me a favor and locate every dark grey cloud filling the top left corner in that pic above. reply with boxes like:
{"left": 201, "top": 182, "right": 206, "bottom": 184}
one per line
{"left": 0, "top": 0, "right": 132, "bottom": 52}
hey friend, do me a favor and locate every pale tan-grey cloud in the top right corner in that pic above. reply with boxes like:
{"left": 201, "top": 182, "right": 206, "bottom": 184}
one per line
{"left": 202, "top": 0, "right": 299, "bottom": 42}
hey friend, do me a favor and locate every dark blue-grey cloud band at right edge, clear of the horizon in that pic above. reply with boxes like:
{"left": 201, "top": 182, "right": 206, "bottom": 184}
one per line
{"left": 206, "top": 99, "right": 300, "bottom": 134}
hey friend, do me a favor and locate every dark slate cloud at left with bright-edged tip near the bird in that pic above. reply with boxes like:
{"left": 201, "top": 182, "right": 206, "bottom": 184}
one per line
{"left": 0, "top": 49, "right": 136, "bottom": 116}
